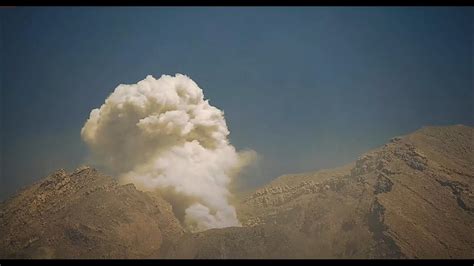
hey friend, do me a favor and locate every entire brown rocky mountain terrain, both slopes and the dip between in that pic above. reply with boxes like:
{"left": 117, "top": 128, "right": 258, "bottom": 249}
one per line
{"left": 0, "top": 125, "right": 474, "bottom": 258}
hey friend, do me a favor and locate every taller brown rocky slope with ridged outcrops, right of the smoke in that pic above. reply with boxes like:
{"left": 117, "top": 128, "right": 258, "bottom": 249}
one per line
{"left": 170, "top": 125, "right": 474, "bottom": 258}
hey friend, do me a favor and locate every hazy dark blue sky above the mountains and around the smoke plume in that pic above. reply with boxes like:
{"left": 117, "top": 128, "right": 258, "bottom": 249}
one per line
{"left": 0, "top": 7, "right": 474, "bottom": 198}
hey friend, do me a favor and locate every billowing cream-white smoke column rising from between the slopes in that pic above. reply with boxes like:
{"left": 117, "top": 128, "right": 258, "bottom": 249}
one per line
{"left": 81, "top": 74, "right": 255, "bottom": 231}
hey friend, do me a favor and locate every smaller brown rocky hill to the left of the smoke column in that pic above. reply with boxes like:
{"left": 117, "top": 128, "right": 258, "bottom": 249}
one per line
{"left": 0, "top": 167, "right": 184, "bottom": 258}
